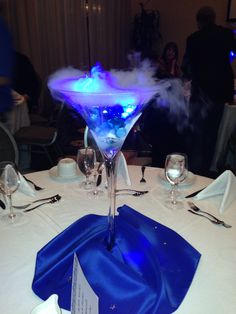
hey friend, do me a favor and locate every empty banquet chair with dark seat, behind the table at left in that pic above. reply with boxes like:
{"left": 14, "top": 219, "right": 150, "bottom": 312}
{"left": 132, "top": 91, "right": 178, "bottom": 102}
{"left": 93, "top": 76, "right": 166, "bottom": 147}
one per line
{"left": 14, "top": 102, "right": 64, "bottom": 166}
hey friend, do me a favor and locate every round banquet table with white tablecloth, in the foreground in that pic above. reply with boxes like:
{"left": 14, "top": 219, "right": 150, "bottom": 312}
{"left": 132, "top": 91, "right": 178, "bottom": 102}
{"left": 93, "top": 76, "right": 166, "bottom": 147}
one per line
{"left": 0, "top": 166, "right": 236, "bottom": 314}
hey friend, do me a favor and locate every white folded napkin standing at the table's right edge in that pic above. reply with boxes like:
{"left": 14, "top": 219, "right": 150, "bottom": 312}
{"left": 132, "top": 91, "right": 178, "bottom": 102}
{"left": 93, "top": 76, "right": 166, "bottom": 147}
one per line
{"left": 194, "top": 170, "right": 236, "bottom": 213}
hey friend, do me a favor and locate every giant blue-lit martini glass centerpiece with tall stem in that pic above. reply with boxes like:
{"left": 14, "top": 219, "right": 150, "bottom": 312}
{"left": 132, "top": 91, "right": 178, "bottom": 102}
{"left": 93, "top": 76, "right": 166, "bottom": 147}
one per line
{"left": 48, "top": 66, "right": 157, "bottom": 249}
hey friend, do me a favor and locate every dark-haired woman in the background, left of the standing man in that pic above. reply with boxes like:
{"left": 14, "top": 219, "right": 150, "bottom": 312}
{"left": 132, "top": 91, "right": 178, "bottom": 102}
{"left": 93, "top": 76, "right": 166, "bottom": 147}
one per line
{"left": 156, "top": 42, "right": 181, "bottom": 79}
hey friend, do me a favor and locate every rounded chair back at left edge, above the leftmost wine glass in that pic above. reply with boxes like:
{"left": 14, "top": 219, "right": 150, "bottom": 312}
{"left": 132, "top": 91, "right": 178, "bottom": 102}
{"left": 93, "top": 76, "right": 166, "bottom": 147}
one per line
{"left": 0, "top": 122, "right": 19, "bottom": 165}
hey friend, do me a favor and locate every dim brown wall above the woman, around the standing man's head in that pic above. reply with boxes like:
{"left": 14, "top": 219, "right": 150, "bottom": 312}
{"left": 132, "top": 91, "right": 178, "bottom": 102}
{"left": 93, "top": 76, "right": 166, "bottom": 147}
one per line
{"left": 131, "top": 0, "right": 236, "bottom": 73}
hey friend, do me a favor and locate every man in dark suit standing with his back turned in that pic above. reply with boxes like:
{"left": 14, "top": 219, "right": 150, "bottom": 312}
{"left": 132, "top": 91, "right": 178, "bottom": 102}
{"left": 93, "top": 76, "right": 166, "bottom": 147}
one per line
{"left": 181, "top": 6, "right": 236, "bottom": 175}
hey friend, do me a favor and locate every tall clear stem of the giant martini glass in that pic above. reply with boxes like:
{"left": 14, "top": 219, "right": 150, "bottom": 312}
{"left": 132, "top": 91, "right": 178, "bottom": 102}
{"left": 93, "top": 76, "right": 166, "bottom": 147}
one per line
{"left": 105, "top": 155, "right": 117, "bottom": 250}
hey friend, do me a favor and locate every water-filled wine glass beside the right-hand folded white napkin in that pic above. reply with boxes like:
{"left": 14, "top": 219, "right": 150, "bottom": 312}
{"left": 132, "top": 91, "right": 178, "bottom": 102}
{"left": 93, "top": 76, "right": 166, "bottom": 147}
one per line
{"left": 165, "top": 153, "right": 187, "bottom": 208}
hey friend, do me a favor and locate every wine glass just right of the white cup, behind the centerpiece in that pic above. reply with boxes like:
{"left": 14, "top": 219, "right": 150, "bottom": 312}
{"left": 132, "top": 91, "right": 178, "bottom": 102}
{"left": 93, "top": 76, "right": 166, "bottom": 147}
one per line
{"left": 77, "top": 147, "right": 96, "bottom": 190}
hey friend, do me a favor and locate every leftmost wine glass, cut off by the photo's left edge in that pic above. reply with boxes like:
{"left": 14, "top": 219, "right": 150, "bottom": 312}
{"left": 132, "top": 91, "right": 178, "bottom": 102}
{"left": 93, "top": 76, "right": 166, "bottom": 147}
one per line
{"left": 0, "top": 161, "right": 23, "bottom": 224}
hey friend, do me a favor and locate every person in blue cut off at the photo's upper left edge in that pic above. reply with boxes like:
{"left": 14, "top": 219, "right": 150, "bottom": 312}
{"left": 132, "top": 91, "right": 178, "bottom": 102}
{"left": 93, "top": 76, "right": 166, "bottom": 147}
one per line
{"left": 0, "top": 12, "right": 13, "bottom": 129}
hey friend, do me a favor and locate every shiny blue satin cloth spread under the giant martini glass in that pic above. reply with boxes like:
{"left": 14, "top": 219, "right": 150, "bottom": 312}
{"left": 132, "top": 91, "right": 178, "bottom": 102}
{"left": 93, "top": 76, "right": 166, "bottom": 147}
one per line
{"left": 32, "top": 205, "right": 201, "bottom": 314}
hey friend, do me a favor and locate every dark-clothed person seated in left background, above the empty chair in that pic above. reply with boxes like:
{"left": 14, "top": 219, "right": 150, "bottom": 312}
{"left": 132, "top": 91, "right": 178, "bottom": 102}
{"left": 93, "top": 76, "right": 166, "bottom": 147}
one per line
{"left": 12, "top": 51, "right": 42, "bottom": 113}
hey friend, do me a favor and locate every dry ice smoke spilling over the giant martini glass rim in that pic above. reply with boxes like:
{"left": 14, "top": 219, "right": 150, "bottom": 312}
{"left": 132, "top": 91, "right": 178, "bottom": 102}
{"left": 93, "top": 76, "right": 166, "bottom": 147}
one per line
{"left": 48, "top": 60, "right": 192, "bottom": 131}
